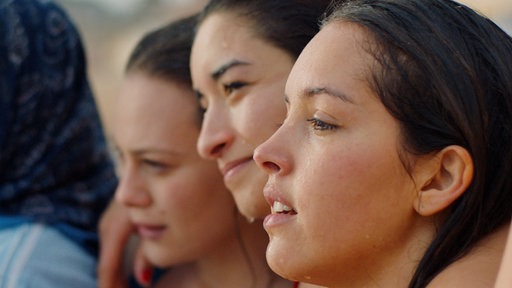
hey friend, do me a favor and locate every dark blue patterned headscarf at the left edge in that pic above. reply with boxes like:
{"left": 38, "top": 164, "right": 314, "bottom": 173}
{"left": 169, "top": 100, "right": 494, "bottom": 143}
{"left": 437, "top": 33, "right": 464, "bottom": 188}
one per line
{"left": 0, "top": 0, "right": 117, "bottom": 249}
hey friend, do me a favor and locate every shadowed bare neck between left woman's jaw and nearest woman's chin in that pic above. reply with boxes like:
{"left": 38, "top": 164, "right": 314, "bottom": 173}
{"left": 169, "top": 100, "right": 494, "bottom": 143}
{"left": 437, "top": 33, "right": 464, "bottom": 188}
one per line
{"left": 156, "top": 216, "right": 292, "bottom": 288}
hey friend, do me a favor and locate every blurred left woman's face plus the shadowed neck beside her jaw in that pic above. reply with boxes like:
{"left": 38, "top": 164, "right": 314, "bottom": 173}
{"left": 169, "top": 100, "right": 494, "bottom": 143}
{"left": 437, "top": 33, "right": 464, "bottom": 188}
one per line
{"left": 114, "top": 70, "right": 289, "bottom": 288}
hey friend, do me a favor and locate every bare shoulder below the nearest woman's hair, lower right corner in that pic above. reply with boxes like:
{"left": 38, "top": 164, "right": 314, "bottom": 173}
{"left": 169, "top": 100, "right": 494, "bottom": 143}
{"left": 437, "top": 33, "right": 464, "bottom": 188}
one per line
{"left": 428, "top": 225, "right": 509, "bottom": 288}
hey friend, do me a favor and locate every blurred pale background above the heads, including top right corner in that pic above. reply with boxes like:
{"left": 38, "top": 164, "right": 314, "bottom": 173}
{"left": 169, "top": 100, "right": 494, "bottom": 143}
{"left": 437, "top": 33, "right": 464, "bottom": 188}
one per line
{"left": 56, "top": 0, "right": 512, "bottom": 134}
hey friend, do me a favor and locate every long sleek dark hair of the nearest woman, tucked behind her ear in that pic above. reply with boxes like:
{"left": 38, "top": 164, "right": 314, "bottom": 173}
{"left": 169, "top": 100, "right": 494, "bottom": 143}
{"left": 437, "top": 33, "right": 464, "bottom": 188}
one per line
{"left": 324, "top": 0, "right": 512, "bottom": 287}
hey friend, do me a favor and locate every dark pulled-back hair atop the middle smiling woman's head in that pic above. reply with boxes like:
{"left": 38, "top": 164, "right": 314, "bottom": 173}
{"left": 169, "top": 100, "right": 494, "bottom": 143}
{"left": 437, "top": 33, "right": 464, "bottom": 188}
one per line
{"left": 195, "top": 0, "right": 331, "bottom": 59}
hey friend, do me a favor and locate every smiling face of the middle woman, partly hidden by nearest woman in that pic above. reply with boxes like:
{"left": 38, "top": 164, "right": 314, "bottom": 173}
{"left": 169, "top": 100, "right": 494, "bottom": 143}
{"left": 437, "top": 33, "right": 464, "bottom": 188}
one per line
{"left": 191, "top": 13, "right": 293, "bottom": 218}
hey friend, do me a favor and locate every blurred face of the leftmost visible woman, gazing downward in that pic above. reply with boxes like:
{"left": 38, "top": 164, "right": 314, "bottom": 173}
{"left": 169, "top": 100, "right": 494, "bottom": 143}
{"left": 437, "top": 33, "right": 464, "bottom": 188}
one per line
{"left": 114, "top": 72, "right": 235, "bottom": 267}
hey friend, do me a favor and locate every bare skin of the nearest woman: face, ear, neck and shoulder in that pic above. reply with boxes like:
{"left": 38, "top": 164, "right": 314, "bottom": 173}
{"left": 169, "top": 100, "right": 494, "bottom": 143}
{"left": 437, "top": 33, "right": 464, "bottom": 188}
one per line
{"left": 254, "top": 21, "right": 507, "bottom": 287}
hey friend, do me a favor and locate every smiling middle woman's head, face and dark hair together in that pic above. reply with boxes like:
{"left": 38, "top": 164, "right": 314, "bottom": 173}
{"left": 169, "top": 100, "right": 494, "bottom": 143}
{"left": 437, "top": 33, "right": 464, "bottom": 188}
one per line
{"left": 102, "top": 0, "right": 330, "bottom": 287}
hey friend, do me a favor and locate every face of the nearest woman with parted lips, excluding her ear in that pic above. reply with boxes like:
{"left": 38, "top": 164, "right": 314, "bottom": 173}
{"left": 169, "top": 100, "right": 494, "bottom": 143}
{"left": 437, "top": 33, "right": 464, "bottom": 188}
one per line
{"left": 255, "top": 22, "right": 426, "bottom": 287}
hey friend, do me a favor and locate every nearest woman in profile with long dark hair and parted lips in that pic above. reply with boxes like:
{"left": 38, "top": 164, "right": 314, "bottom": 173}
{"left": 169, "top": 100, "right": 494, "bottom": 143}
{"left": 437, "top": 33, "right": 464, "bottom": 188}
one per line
{"left": 255, "top": 0, "right": 512, "bottom": 287}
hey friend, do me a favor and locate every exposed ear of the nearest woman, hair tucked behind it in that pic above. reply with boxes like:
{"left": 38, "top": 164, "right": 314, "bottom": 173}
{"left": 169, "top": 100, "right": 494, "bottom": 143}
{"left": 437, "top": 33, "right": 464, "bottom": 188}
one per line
{"left": 414, "top": 145, "right": 474, "bottom": 216}
